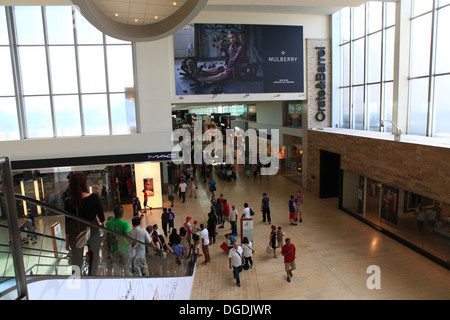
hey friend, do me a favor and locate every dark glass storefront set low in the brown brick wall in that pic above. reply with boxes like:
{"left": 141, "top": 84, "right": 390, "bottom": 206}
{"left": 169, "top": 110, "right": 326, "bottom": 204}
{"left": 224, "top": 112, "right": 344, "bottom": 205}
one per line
{"left": 340, "top": 170, "right": 450, "bottom": 265}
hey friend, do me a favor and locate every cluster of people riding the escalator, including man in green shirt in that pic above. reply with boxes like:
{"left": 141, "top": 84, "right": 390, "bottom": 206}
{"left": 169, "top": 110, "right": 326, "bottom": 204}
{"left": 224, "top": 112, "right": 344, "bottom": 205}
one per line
{"left": 65, "top": 172, "right": 193, "bottom": 276}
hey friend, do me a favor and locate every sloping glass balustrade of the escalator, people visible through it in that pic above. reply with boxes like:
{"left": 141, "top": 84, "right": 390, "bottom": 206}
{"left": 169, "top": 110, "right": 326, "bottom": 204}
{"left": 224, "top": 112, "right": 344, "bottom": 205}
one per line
{"left": 0, "top": 158, "right": 195, "bottom": 299}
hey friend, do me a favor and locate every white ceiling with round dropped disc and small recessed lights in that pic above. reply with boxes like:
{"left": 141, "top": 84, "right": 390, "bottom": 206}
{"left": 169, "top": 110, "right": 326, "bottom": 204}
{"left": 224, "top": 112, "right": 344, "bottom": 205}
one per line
{"left": 1, "top": 0, "right": 370, "bottom": 41}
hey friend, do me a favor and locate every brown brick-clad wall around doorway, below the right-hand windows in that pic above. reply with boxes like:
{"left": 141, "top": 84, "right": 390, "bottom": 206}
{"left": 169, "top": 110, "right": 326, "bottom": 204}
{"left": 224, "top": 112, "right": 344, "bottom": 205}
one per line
{"left": 306, "top": 130, "right": 450, "bottom": 203}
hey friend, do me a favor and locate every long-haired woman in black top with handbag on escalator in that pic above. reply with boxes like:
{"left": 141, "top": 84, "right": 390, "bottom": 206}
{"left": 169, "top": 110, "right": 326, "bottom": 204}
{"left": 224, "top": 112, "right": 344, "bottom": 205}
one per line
{"left": 64, "top": 172, "right": 105, "bottom": 276}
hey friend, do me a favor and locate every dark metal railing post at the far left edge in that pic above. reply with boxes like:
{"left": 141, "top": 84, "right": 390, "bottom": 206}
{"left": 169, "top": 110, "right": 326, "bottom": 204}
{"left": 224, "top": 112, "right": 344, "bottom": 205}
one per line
{"left": 0, "top": 157, "right": 28, "bottom": 299}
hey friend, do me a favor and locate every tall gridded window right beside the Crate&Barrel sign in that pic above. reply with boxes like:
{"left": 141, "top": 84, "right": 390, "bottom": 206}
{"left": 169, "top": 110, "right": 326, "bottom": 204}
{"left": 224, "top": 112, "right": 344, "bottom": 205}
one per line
{"left": 338, "top": 2, "right": 396, "bottom": 131}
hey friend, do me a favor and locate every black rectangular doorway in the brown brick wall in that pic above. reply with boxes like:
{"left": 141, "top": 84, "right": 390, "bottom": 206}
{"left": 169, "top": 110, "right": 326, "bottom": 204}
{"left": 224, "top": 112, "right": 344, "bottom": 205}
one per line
{"left": 319, "top": 150, "right": 341, "bottom": 198}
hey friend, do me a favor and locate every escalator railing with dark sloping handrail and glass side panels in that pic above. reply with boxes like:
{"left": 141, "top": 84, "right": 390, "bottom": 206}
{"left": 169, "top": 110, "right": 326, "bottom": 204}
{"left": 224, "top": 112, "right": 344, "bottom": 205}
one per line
{"left": 0, "top": 158, "right": 196, "bottom": 299}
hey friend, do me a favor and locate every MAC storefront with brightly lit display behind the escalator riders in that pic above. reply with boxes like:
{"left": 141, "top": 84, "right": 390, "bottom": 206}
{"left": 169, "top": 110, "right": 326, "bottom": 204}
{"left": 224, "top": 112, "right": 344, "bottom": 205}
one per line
{"left": 13, "top": 155, "right": 173, "bottom": 216}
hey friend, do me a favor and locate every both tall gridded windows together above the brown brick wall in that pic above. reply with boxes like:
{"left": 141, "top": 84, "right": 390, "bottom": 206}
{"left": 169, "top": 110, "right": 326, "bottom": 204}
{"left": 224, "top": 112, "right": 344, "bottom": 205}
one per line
{"left": 333, "top": 0, "right": 450, "bottom": 138}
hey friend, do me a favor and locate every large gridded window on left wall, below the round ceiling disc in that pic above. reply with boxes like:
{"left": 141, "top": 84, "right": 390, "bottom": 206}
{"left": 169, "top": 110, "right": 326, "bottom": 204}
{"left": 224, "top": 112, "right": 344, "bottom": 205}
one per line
{"left": 0, "top": 6, "right": 137, "bottom": 140}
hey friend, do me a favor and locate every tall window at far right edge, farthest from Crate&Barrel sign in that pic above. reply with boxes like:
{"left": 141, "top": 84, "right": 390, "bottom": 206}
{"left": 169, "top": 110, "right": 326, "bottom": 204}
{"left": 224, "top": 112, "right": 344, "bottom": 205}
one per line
{"left": 408, "top": 0, "right": 450, "bottom": 138}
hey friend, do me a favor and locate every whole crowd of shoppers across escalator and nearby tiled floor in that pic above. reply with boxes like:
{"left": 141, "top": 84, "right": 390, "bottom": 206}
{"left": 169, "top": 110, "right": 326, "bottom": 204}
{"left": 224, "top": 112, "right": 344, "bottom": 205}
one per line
{"left": 65, "top": 169, "right": 304, "bottom": 286}
